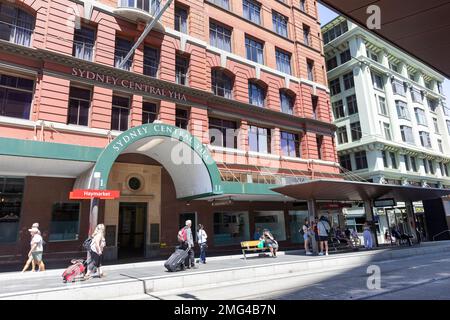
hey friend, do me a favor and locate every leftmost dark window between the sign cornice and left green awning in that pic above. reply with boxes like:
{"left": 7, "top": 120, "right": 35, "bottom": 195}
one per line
{"left": 0, "top": 74, "right": 34, "bottom": 120}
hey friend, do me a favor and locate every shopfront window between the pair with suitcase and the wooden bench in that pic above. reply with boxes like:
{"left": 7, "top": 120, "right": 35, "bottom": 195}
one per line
{"left": 214, "top": 212, "right": 250, "bottom": 246}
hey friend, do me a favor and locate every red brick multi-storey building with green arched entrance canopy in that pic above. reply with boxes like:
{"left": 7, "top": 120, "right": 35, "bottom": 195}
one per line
{"left": 0, "top": 0, "right": 339, "bottom": 262}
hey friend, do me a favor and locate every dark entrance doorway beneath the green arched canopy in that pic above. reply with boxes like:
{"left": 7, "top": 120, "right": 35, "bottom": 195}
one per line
{"left": 117, "top": 202, "right": 147, "bottom": 259}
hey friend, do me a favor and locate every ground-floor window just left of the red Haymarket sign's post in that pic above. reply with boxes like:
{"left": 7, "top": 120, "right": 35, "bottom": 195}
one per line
{"left": 48, "top": 203, "right": 80, "bottom": 241}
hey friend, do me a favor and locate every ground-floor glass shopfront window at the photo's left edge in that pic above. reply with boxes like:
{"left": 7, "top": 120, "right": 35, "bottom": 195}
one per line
{"left": 0, "top": 177, "right": 25, "bottom": 243}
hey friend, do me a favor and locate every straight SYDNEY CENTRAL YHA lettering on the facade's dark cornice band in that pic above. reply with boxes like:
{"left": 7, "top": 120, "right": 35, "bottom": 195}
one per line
{"left": 72, "top": 68, "right": 187, "bottom": 101}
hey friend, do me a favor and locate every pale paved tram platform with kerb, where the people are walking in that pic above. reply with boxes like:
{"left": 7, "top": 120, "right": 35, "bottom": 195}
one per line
{"left": 0, "top": 241, "right": 450, "bottom": 299}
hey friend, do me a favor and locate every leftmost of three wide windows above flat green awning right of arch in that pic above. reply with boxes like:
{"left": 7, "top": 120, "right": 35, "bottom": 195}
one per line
{"left": 209, "top": 118, "right": 238, "bottom": 149}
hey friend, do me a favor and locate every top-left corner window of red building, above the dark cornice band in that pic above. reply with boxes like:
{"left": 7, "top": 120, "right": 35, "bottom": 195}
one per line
{"left": 0, "top": 2, "right": 34, "bottom": 47}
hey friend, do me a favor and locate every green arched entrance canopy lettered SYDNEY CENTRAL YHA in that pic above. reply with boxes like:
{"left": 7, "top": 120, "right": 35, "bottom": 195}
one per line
{"left": 75, "top": 123, "right": 223, "bottom": 199}
